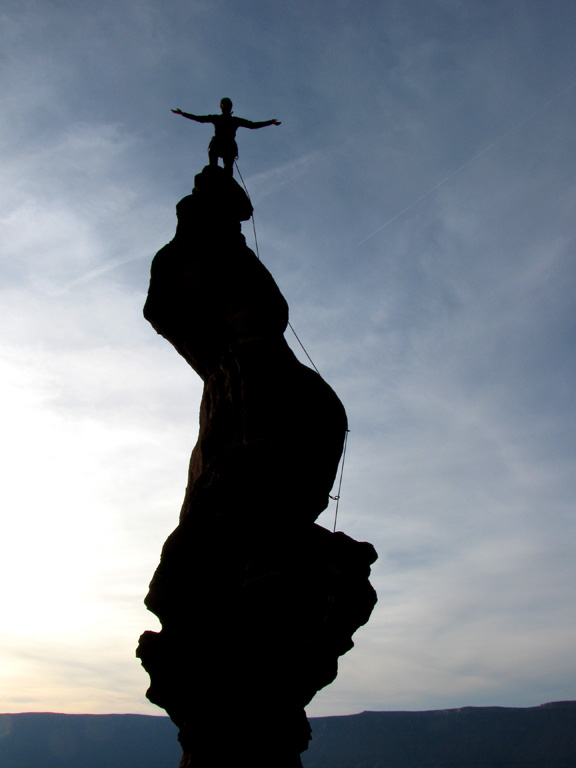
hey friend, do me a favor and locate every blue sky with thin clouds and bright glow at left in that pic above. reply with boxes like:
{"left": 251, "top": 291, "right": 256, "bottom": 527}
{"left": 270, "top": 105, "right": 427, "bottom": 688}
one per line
{"left": 0, "top": 0, "right": 576, "bottom": 716}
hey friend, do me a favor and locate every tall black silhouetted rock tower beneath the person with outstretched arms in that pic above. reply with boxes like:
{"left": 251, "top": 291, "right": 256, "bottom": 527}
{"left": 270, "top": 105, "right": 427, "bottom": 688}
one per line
{"left": 137, "top": 167, "right": 376, "bottom": 768}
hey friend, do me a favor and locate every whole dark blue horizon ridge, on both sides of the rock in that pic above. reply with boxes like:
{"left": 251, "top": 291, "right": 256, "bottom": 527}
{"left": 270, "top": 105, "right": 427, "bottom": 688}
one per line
{"left": 0, "top": 701, "right": 576, "bottom": 768}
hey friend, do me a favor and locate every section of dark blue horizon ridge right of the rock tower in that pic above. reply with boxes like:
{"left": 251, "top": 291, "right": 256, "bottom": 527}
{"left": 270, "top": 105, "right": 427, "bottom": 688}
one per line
{"left": 304, "top": 702, "right": 576, "bottom": 768}
